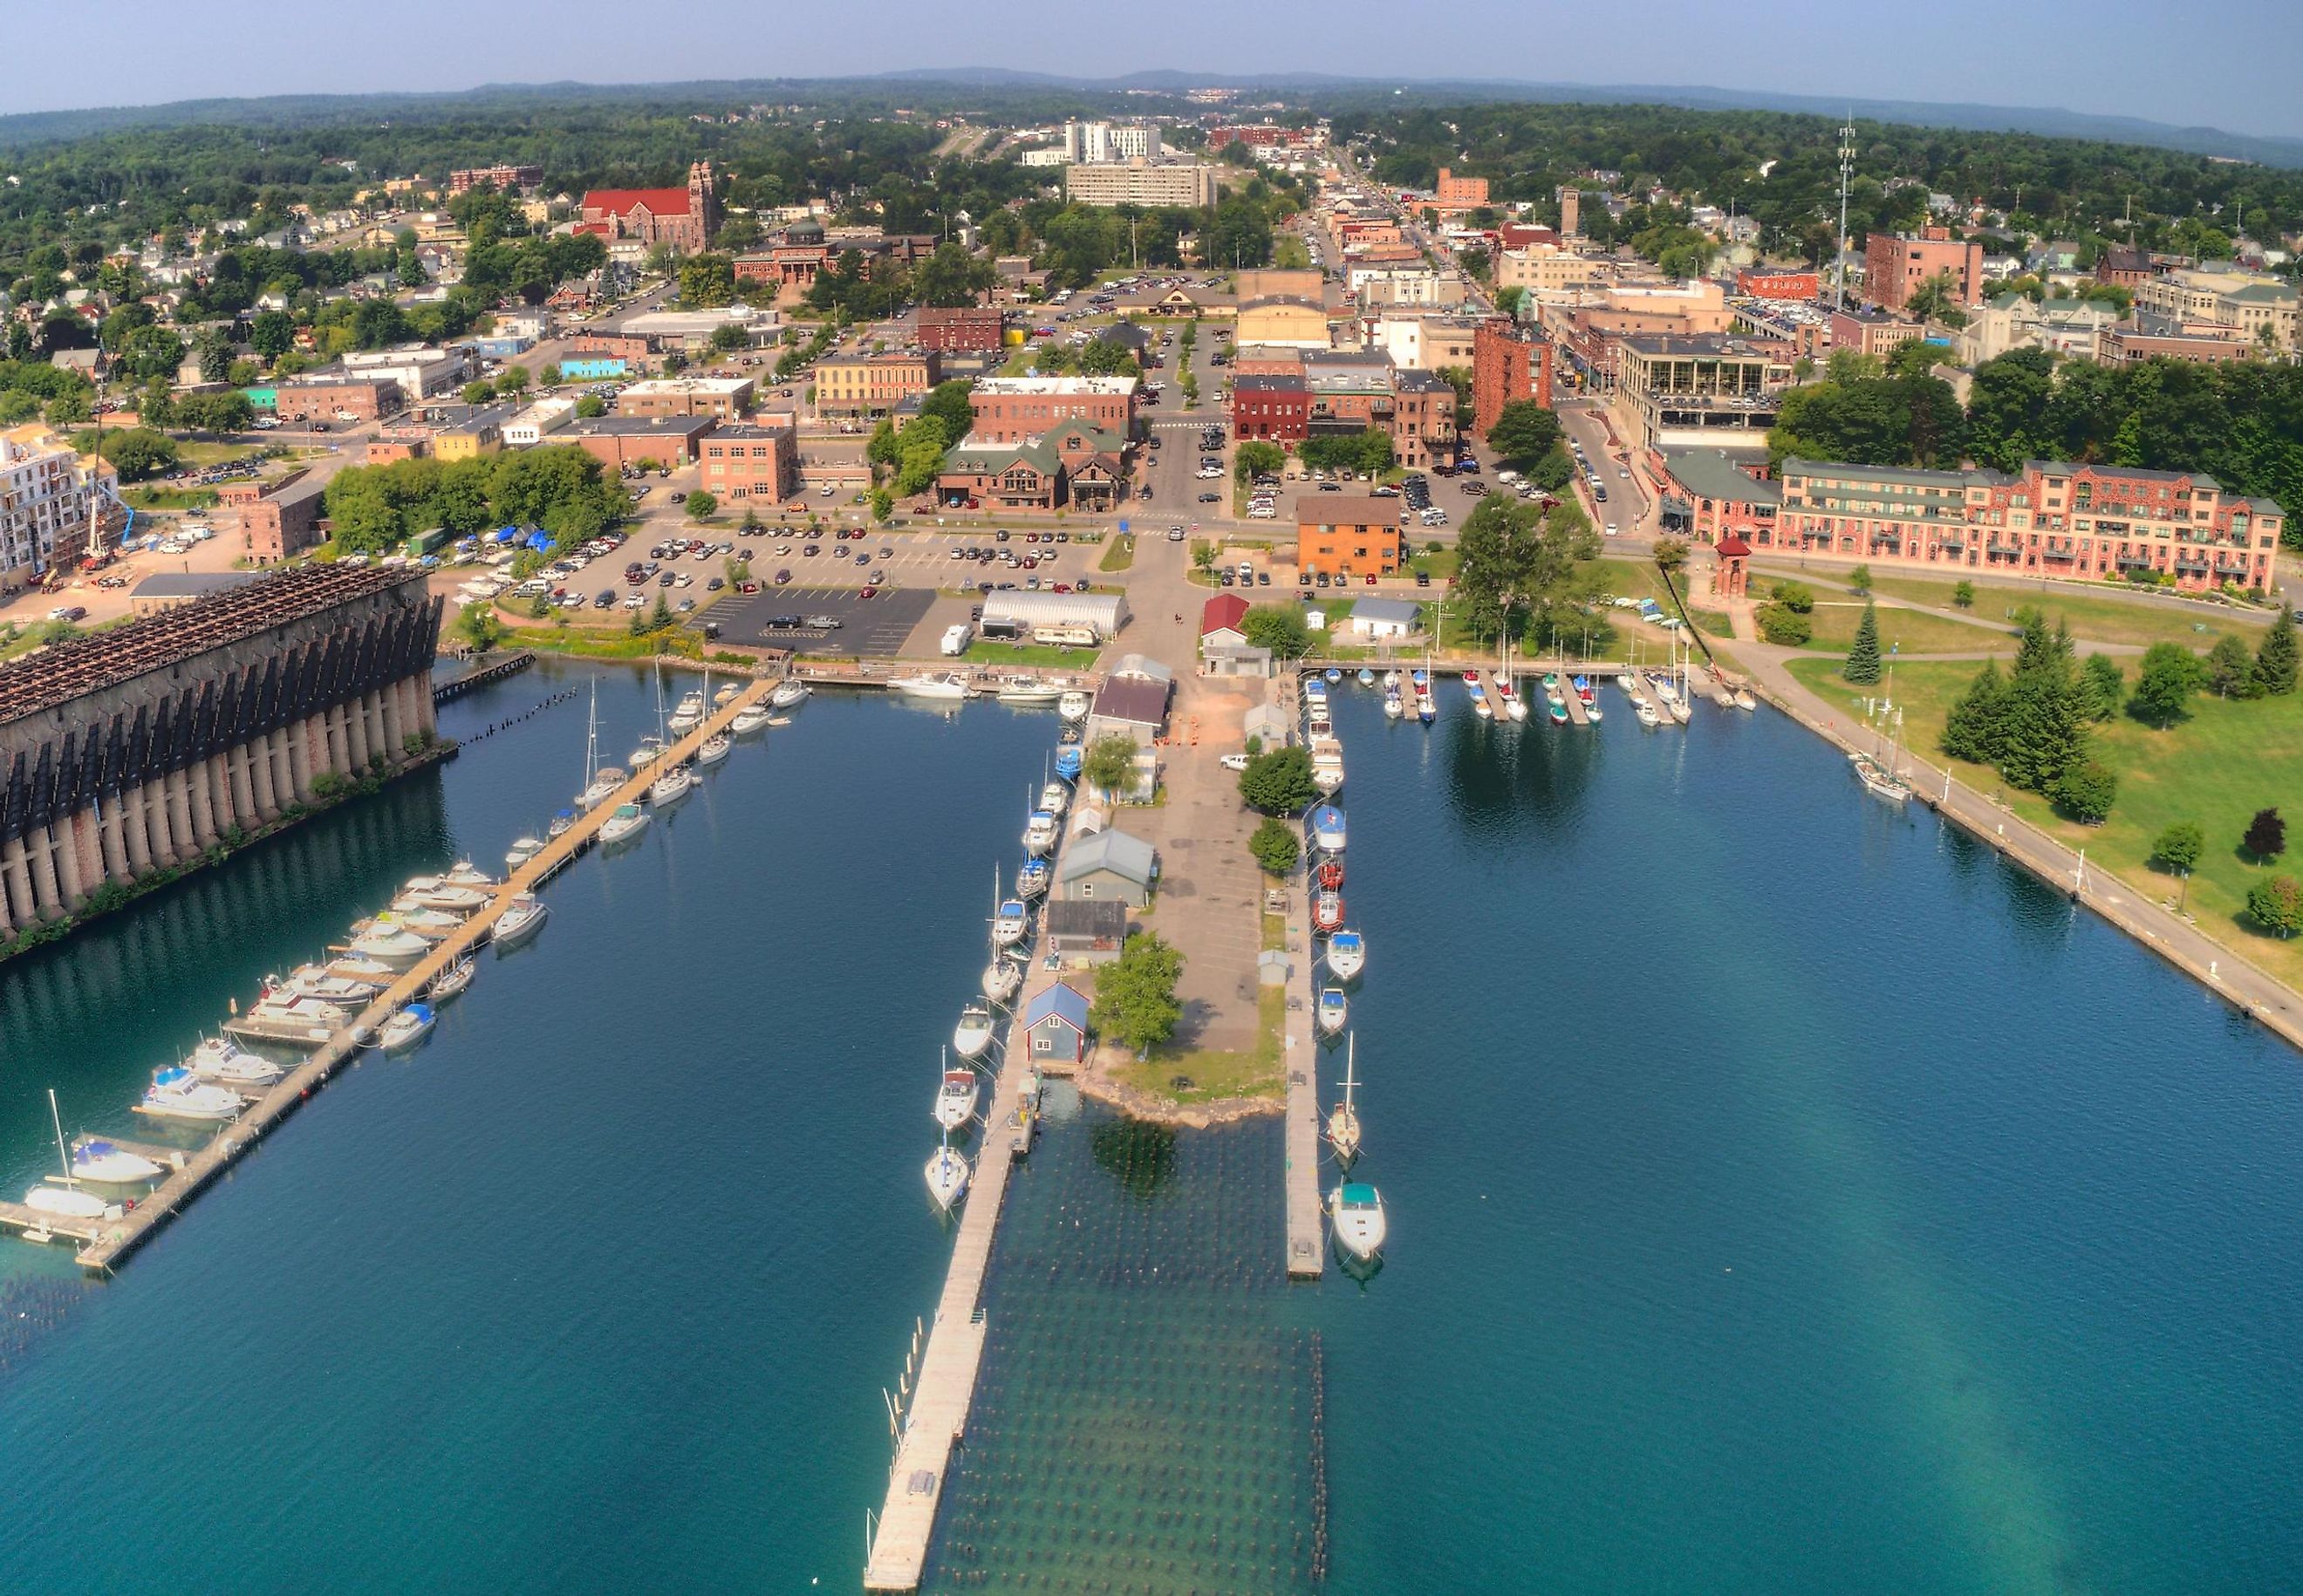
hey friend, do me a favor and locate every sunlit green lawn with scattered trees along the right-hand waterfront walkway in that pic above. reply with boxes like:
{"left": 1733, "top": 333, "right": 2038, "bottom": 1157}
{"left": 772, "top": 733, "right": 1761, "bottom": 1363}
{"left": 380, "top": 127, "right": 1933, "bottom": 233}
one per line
{"left": 1792, "top": 658, "right": 2303, "bottom": 986}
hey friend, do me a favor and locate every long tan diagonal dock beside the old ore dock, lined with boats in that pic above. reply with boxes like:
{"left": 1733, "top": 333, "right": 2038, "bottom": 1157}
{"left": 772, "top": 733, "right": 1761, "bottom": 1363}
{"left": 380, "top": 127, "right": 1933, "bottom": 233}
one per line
{"left": 0, "top": 679, "right": 774, "bottom": 1273}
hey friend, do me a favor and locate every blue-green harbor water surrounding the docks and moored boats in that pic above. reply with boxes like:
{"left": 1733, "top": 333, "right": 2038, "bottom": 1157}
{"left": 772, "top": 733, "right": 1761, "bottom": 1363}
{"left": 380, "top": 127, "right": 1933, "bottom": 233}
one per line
{"left": 0, "top": 670, "right": 2303, "bottom": 1596}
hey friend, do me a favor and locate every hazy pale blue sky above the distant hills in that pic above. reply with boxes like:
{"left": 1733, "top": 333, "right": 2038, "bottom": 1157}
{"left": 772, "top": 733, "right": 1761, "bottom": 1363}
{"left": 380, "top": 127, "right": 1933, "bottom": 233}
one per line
{"left": 17, "top": 0, "right": 2303, "bottom": 136}
